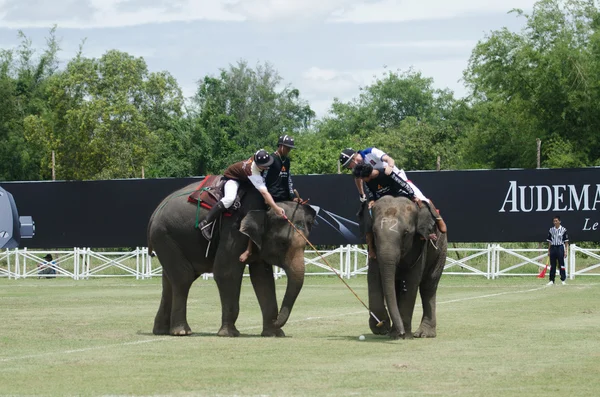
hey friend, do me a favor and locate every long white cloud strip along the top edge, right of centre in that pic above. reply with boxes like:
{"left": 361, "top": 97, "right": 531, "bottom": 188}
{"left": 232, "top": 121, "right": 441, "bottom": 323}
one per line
{"left": 330, "top": 0, "right": 536, "bottom": 23}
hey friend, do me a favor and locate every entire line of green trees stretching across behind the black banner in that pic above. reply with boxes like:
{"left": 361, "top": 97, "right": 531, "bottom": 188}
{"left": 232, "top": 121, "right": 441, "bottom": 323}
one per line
{"left": 0, "top": 0, "right": 600, "bottom": 181}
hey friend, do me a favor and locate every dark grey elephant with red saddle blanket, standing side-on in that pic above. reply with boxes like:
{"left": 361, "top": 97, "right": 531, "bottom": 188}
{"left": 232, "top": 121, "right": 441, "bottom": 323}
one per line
{"left": 148, "top": 183, "right": 316, "bottom": 337}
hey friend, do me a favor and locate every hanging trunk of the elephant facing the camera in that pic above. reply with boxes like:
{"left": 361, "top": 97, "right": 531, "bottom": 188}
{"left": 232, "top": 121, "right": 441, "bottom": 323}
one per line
{"left": 377, "top": 247, "right": 406, "bottom": 336}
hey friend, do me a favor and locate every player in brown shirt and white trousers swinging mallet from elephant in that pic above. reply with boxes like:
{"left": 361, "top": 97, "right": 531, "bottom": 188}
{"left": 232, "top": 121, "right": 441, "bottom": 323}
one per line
{"left": 198, "top": 149, "right": 285, "bottom": 256}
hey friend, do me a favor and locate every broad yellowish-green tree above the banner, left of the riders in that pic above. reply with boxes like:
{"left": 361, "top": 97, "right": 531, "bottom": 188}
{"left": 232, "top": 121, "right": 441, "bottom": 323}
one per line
{"left": 25, "top": 50, "right": 183, "bottom": 180}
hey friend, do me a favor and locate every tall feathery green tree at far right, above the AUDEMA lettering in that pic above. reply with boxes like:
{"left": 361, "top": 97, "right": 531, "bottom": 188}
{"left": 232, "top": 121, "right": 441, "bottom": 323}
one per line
{"left": 464, "top": 0, "right": 600, "bottom": 167}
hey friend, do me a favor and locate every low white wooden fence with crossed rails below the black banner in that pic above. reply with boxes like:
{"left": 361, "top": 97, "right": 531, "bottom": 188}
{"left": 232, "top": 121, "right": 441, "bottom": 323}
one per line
{"left": 0, "top": 244, "right": 600, "bottom": 280}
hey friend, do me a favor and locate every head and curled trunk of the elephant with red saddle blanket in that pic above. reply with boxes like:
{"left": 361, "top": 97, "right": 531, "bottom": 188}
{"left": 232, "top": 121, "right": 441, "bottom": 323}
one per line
{"left": 240, "top": 202, "right": 316, "bottom": 328}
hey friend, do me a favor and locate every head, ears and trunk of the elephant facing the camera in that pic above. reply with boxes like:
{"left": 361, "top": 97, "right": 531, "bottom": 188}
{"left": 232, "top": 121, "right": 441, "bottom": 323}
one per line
{"left": 372, "top": 196, "right": 434, "bottom": 336}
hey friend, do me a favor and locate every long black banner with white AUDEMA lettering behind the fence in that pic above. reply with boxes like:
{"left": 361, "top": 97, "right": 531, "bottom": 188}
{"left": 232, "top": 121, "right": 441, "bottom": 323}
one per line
{"left": 0, "top": 168, "right": 600, "bottom": 248}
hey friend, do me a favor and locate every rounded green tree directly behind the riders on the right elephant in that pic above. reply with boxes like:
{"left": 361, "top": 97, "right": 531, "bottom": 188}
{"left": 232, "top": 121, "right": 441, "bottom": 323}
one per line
{"left": 316, "top": 70, "right": 461, "bottom": 169}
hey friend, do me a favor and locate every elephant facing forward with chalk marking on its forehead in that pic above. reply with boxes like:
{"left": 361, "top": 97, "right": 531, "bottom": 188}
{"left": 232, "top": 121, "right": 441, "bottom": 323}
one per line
{"left": 367, "top": 196, "right": 448, "bottom": 339}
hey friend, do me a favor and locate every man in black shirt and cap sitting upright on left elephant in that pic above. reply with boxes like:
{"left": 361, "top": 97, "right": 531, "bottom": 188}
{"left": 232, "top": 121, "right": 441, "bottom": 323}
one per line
{"left": 265, "top": 135, "right": 295, "bottom": 202}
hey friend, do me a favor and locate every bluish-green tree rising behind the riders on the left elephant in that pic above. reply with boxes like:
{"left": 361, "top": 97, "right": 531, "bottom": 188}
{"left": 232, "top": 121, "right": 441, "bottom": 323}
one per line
{"left": 191, "top": 61, "right": 315, "bottom": 174}
